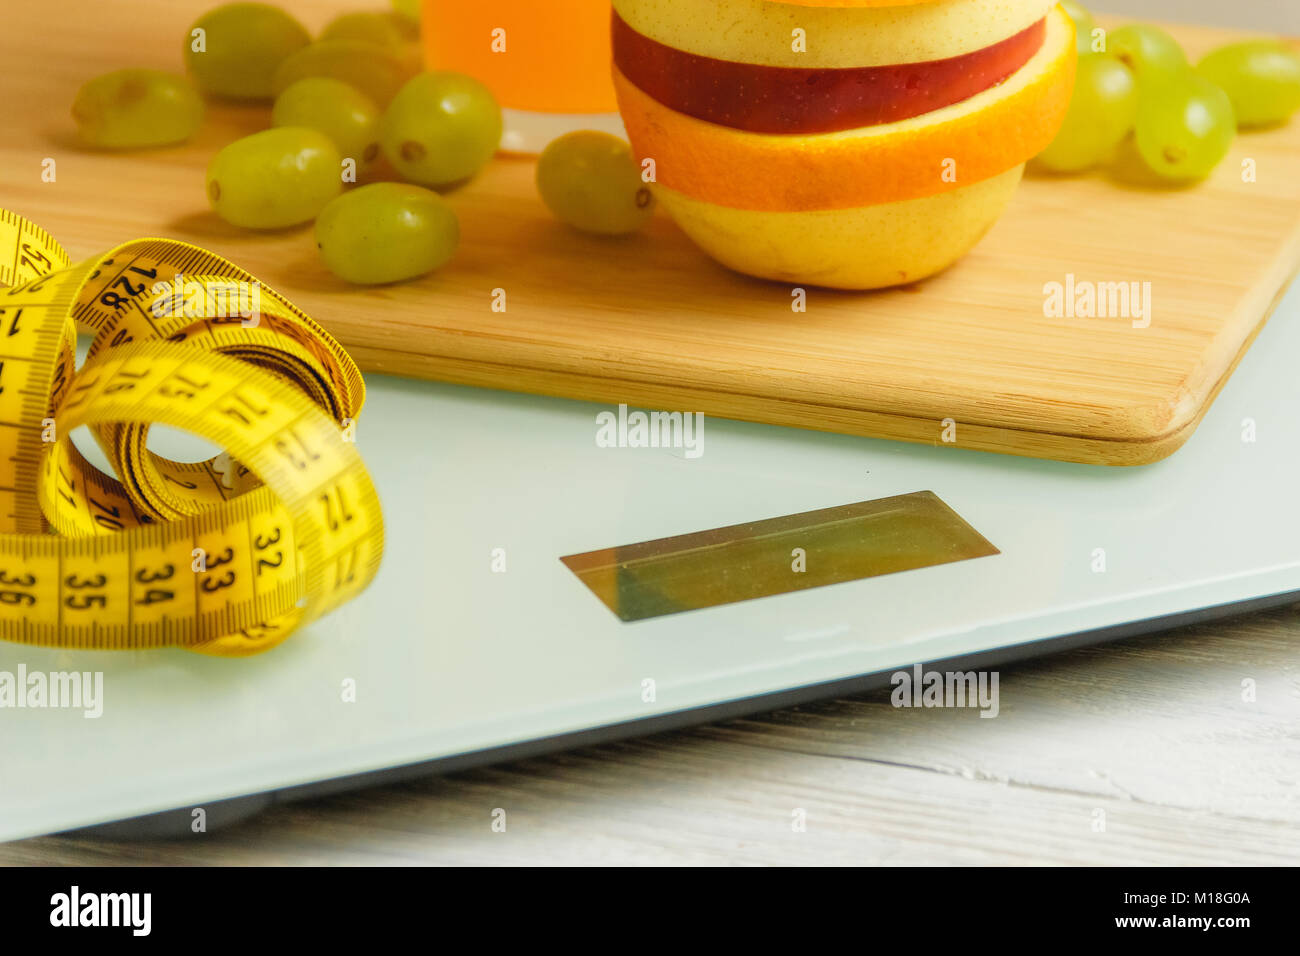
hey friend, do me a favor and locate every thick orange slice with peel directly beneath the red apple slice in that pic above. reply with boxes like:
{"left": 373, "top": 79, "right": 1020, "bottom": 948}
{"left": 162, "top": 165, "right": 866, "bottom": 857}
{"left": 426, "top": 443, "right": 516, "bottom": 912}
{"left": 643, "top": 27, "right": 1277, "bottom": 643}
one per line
{"left": 614, "top": 8, "right": 1076, "bottom": 211}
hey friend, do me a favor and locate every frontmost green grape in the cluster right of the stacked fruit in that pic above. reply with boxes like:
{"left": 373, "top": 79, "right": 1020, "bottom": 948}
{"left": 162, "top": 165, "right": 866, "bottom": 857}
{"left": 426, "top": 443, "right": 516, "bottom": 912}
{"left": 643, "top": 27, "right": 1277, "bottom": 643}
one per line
{"left": 1134, "top": 70, "right": 1236, "bottom": 181}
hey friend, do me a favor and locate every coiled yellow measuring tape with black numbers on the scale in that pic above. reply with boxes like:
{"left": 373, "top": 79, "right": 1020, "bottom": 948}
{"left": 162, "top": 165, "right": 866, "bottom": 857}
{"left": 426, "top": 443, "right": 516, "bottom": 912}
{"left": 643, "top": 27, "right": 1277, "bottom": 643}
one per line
{"left": 0, "top": 209, "right": 384, "bottom": 657}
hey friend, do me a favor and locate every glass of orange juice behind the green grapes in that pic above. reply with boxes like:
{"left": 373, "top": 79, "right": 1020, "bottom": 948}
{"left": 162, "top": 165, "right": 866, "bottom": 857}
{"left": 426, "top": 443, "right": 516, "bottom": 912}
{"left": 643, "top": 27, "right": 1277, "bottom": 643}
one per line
{"left": 423, "top": 0, "right": 625, "bottom": 152}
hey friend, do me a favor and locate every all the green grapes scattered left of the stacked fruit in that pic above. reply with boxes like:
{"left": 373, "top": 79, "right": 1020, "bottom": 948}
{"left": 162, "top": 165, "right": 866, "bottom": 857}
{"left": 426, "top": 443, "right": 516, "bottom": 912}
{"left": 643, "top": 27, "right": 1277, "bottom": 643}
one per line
{"left": 73, "top": 0, "right": 651, "bottom": 284}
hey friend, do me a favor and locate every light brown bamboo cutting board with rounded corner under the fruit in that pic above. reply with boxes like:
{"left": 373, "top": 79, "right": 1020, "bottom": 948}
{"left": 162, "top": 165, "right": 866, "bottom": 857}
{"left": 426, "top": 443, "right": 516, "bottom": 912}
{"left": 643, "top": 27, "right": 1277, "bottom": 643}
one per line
{"left": 0, "top": 0, "right": 1300, "bottom": 464}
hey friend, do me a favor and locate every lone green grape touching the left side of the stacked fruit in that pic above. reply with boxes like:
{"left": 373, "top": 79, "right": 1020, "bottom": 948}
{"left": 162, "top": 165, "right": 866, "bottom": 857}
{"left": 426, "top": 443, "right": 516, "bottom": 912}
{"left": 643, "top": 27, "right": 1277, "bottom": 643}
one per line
{"left": 537, "top": 130, "right": 654, "bottom": 235}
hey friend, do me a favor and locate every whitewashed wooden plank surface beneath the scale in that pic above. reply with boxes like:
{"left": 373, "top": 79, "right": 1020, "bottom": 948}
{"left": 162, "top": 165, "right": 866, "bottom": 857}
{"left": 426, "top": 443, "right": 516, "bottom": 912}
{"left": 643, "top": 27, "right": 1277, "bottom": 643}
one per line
{"left": 0, "top": 605, "right": 1300, "bottom": 865}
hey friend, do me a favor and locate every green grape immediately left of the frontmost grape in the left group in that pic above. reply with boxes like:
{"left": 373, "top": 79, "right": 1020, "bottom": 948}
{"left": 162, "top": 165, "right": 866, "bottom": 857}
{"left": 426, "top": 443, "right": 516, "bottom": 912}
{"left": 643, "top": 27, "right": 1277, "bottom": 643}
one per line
{"left": 208, "top": 126, "right": 343, "bottom": 229}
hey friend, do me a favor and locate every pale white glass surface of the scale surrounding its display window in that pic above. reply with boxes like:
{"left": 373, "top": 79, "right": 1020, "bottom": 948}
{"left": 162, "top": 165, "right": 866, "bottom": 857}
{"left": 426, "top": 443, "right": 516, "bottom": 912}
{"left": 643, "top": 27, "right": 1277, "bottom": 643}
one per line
{"left": 0, "top": 280, "right": 1300, "bottom": 839}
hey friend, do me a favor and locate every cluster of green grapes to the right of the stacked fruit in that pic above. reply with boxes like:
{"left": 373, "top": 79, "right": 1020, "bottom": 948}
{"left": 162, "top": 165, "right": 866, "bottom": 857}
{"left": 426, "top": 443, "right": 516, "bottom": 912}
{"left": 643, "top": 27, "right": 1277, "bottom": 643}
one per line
{"left": 1037, "top": 0, "right": 1300, "bottom": 182}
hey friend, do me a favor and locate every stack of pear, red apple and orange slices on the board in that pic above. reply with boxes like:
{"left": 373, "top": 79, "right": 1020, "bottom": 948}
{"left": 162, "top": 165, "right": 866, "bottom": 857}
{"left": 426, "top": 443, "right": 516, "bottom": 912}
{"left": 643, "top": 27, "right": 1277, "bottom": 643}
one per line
{"left": 612, "top": 0, "right": 1075, "bottom": 289}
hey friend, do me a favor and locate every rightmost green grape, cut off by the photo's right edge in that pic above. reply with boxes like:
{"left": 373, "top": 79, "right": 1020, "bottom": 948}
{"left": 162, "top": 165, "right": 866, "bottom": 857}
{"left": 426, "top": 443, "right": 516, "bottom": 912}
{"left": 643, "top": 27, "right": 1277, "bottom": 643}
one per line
{"left": 1196, "top": 40, "right": 1300, "bottom": 126}
